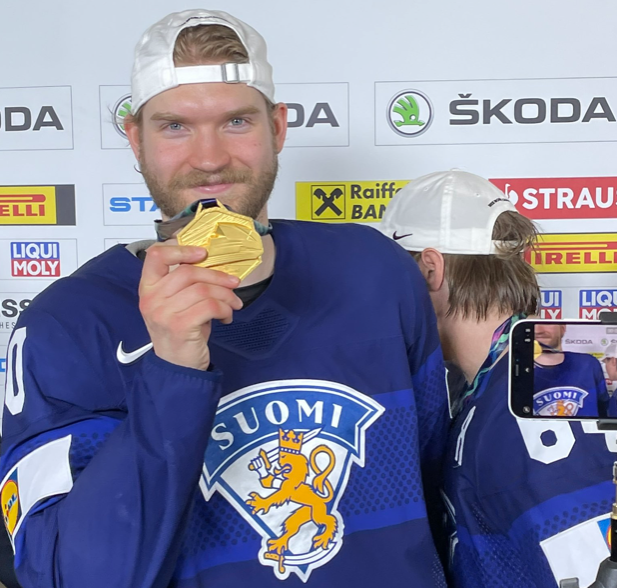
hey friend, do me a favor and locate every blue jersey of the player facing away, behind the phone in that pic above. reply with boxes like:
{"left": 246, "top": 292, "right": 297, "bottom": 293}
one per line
{"left": 444, "top": 354, "right": 617, "bottom": 588}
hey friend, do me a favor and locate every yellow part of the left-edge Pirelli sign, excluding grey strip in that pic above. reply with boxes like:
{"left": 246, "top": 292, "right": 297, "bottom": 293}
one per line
{"left": 0, "top": 186, "right": 57, "bottom": 225}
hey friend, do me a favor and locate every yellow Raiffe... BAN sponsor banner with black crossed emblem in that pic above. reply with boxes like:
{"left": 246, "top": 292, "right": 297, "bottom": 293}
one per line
{"left": 296, "top": 180, "right": 410, "bottom": 223}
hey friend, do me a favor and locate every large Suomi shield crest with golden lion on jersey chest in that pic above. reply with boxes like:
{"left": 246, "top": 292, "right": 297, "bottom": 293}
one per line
{"left": 200, "top": 380, "right": 384, "bottom": 582}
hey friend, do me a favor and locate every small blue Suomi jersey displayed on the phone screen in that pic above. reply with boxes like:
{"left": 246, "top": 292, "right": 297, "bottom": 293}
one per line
{"left": 533, "top": 351, "right": 617, "bottom": 418}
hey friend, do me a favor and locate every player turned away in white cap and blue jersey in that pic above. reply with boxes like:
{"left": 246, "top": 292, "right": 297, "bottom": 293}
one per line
{"left": 382, "top": 171, "right": 616, "bottom": 588}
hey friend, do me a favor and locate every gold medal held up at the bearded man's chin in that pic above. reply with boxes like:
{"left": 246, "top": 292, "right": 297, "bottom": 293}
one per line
{"left": 176, "top": 202, "right": 264, "bottom": 280}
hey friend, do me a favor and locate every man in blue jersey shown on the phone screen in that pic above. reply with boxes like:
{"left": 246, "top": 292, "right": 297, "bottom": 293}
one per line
{"left": 533, "top": 323, "right": 617, "bottom": 418}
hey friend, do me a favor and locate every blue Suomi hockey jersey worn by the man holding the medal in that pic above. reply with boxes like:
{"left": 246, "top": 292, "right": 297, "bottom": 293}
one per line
{"left": 1, "top": 221, "right": 448, "bottom": 588}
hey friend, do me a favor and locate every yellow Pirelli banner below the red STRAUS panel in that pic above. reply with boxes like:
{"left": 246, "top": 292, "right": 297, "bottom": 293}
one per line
{"left": 525, "top": 233, "right": 617, "bottom": 274}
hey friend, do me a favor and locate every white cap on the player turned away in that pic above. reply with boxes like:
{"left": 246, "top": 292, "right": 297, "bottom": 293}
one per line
{"left": 380, "top": 170, "right": 517, "bottom": 255}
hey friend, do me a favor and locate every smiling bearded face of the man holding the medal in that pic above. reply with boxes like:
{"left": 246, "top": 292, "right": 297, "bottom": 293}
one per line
{"left": 127, "top": 82, "right": 287, "bottom": 220}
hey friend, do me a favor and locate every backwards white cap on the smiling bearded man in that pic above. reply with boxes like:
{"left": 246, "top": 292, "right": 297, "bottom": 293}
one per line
{"left": 131, "top": 9, "right": 274, "bottom": 114}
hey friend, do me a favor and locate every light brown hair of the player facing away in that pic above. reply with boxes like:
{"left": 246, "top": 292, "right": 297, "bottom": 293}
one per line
{"left": 413, "top": 211, "right": 540, "bottom": 321}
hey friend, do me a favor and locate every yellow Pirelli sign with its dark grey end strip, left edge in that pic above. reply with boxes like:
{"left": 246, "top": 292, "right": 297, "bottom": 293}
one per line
{"left": 0, "top": 185, "right": 75, "bottom": 225}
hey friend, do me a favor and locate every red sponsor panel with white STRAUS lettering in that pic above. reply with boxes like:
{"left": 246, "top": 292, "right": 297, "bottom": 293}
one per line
{"left": 491, "top": 177, "right": 617, "bottom": 219}
